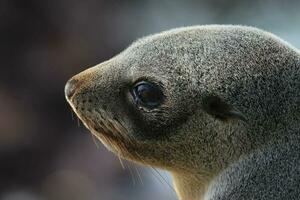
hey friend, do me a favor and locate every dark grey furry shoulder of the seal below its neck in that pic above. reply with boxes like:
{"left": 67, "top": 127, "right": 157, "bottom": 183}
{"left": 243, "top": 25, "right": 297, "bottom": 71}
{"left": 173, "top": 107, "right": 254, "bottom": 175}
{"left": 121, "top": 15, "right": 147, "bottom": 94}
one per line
{"left": 205, "top": 131, "right": 300, "bottom": 200}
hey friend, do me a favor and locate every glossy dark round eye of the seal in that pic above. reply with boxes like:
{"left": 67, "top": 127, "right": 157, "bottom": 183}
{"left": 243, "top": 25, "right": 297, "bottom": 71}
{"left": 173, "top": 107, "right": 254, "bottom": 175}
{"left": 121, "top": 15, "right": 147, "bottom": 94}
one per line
{"left": 132, "top": 81, "right": 164, "bottom": 109}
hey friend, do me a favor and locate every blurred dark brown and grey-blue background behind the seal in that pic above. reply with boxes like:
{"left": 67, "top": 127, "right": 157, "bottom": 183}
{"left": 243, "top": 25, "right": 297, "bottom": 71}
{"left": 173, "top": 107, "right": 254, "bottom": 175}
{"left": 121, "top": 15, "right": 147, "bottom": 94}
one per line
{"left": 0, "top": 0, "right": 300, "bottom": 200}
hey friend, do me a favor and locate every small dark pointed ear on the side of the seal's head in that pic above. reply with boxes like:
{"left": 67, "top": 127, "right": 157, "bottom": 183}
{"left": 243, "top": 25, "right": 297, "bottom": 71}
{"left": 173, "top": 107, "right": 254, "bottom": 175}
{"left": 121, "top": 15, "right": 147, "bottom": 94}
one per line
{"left": 202, "top": 96, "right": 247, "bottom": 122}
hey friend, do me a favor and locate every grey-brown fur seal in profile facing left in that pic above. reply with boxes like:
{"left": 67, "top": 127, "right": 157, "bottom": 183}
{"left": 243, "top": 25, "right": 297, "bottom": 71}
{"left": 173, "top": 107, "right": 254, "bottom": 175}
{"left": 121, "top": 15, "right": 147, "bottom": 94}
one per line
{"left": 65, "top": 25, "right": 300, "bottom": 200}
